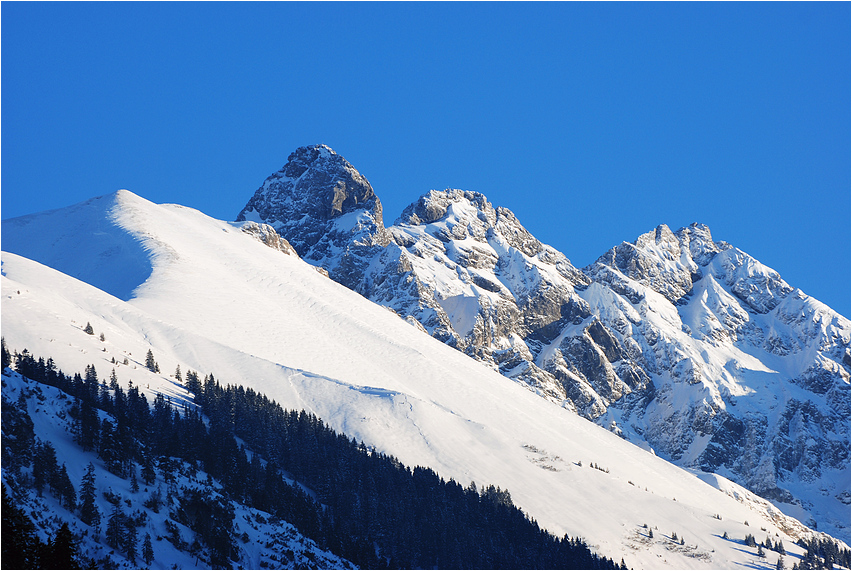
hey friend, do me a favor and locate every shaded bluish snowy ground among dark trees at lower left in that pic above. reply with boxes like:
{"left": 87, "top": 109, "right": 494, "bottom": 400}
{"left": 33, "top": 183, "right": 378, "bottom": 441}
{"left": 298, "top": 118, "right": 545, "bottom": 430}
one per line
{"left": 2, "top": 371, "right": 353, "bottom": 569}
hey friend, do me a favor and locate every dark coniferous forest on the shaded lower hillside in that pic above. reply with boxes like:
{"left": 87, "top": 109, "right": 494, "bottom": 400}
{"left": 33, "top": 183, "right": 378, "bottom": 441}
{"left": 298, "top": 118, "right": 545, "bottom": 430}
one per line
{"left": 2, "top": 343, "right": 623, "bottom": 569}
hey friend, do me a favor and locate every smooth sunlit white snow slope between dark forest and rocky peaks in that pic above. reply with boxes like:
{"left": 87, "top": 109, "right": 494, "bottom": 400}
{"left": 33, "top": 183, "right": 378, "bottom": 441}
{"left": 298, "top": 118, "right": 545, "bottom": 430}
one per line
{"left": 2, "top": 191, "right": 844, "bottom": 568}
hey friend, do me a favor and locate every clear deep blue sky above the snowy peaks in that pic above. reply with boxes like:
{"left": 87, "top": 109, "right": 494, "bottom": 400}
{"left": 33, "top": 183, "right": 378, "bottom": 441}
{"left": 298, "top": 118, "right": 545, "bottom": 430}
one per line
{"left": 0, "top": 2, "right": 852, "bottom": 317}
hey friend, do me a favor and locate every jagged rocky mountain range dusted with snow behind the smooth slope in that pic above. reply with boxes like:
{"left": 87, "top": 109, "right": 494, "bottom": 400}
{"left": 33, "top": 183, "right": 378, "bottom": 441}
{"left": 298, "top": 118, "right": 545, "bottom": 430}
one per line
{"left": 238, "top": 145, "right": 850, "bottom": 540}
